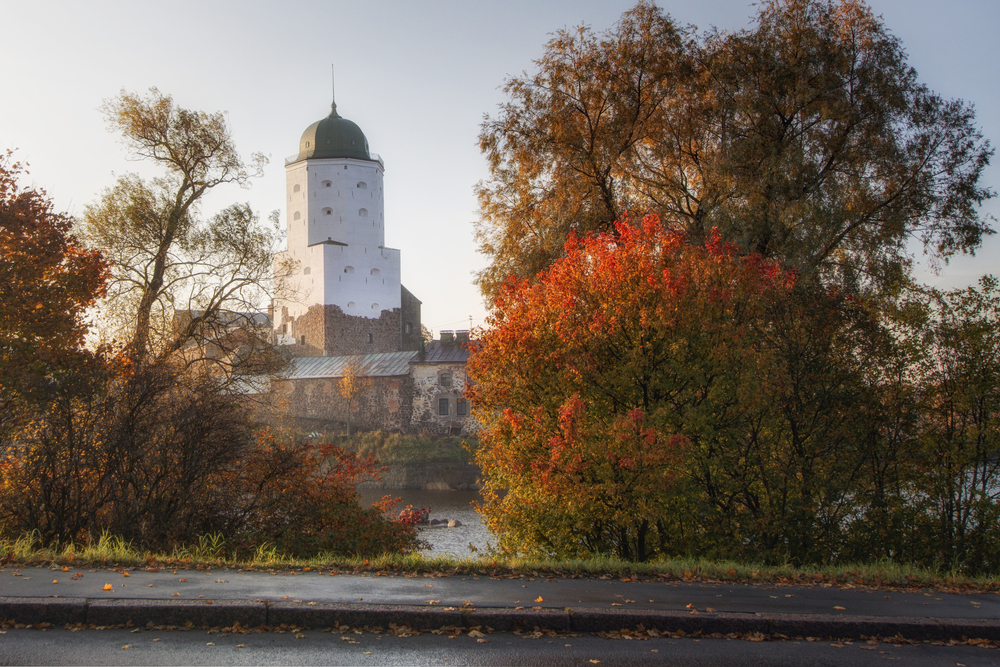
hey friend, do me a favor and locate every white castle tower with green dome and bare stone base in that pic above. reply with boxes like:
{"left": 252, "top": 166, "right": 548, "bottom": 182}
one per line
{"left": 274, "top": 96, "right": 420, "bottom": 356}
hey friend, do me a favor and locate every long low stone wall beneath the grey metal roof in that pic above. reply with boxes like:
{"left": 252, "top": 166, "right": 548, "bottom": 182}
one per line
{"left": 276, "top": 375, "right": 413, "bottom": 431}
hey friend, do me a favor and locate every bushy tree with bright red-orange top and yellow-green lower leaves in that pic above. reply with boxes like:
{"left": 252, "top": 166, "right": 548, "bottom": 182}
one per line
{"left": 469, "top": 216, "right": 795, "bottom": 560}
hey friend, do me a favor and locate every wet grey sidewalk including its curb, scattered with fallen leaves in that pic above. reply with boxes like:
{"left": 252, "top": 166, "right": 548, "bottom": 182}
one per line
{"left": 0, "top": 567, "right": 1000, "bottom": 641}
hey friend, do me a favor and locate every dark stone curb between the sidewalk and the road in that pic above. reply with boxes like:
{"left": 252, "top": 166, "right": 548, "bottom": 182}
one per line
{"left": 0, "top": 597, "right": 1000, "bottom": 641}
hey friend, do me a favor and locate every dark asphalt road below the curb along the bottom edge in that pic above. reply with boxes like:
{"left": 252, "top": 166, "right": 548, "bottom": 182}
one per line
{"left": 0, "top": 629, "right": 1000, "bottom": 667}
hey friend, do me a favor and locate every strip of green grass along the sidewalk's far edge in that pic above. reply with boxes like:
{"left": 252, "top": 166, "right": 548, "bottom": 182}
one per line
{"left": 0, "top": 536, "right": 1000, "bottom": 593}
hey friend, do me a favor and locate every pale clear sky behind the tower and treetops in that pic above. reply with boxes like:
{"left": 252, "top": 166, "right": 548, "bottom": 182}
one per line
{"left": 0, "top": 0, "right": 1000, "bottom": 334}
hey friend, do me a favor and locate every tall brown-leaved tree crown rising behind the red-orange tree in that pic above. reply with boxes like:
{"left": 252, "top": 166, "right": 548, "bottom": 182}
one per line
{"left": 477, "top": 0, "right": 993, "bottom": 295}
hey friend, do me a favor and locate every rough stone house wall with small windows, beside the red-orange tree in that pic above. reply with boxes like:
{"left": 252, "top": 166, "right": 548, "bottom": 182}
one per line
{"left": 410, "top": 362, "right": 480, "bottom": 435}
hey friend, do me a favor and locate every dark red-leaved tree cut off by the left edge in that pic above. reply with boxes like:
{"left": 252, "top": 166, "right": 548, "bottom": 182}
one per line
{"left": 0, "top": 152, "right": 107, "bottom": 434}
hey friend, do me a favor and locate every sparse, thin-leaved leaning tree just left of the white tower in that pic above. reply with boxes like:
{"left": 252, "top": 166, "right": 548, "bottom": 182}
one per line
{"left": 83, "top": 88, "right": 288, "bottom": 384}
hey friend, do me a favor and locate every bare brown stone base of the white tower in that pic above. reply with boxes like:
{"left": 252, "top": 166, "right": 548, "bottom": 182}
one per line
{"left": 281, "top": 304, "right": 404, "bottom": 357}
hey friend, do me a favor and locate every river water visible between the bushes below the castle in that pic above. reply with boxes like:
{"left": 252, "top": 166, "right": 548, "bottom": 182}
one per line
{"left": 358, "top": 489, "right": 491, "bottom": 558}
